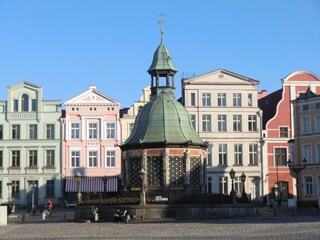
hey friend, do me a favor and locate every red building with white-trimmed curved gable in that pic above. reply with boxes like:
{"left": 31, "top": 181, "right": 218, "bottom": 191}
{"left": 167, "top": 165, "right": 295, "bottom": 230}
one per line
{"left": 259, "top": 71, "right": 320, "bottom": 206}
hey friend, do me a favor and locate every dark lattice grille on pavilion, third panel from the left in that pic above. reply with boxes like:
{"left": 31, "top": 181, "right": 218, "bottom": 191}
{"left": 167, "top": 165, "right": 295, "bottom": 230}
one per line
{"left": 169, "top": 157, "right": 186, "bottom": 186}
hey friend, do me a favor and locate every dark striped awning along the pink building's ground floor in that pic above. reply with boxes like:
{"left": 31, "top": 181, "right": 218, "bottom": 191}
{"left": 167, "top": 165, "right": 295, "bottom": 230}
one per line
{"left": 65, "top": 177, "right": 118, "bottom": 192}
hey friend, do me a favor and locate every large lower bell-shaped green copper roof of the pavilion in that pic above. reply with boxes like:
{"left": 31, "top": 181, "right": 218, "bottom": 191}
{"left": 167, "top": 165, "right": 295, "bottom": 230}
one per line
{"left": 122, "top": 88, "right": 205, "bottom": 148}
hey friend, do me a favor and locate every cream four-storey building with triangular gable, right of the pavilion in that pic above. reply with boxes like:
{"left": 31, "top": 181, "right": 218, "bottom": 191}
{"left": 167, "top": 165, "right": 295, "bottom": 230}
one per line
{"left": 182, "top": 69, "right": 264, "bottom": 200}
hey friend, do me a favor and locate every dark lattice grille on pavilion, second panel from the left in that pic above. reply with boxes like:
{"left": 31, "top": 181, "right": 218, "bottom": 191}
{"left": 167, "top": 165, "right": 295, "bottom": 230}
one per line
{"left": 147, "top": 156, "right": 163, "bottom": 186}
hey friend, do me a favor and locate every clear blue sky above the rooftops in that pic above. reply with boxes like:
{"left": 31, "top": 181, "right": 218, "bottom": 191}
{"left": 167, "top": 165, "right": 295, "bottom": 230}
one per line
{"left": 0, "top": 0, "right": 320, "bottom": 107}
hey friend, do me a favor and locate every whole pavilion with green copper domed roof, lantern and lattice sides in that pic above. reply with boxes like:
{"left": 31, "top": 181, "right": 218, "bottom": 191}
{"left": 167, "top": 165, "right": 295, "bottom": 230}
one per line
{"left": 120, "top": 28, "right": 207, "bottom": 197}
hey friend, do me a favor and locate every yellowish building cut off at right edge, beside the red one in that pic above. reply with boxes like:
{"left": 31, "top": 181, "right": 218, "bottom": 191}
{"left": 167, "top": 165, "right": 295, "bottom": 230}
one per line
{"left": 289, "top": 86, "right": 320, "bottom": 207}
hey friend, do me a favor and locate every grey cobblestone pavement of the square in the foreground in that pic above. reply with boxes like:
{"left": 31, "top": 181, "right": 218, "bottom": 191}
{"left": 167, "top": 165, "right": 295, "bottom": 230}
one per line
{"left": 0, "top": 211, "right": 320, "bottom": 240}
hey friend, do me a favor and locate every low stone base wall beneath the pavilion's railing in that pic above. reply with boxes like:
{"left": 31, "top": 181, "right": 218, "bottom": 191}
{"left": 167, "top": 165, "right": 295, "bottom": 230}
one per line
{"left": 75, "top": 204, "right": 260, "bottom": 222}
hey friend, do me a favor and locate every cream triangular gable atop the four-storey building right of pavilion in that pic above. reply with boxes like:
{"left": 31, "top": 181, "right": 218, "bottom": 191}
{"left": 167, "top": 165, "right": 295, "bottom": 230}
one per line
{"left": 183, "top": 68, "right": 259, "bottom": 85}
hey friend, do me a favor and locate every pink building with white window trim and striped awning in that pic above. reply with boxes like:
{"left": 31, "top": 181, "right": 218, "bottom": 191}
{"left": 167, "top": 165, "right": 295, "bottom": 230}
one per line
{"left": 62, "top": 86, "right": 121, "bottom": 200}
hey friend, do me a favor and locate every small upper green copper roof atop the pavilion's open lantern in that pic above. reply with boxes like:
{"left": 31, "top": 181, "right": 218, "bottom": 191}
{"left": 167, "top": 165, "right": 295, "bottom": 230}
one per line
{"left": 148, "top": 41, "right": 177, "bottom": 74}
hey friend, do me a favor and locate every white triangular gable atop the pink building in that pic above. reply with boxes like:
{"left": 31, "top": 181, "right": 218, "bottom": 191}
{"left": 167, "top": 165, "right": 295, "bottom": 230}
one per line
{"left": 65, "top": 87, "right": 120, "bottom": 105}
